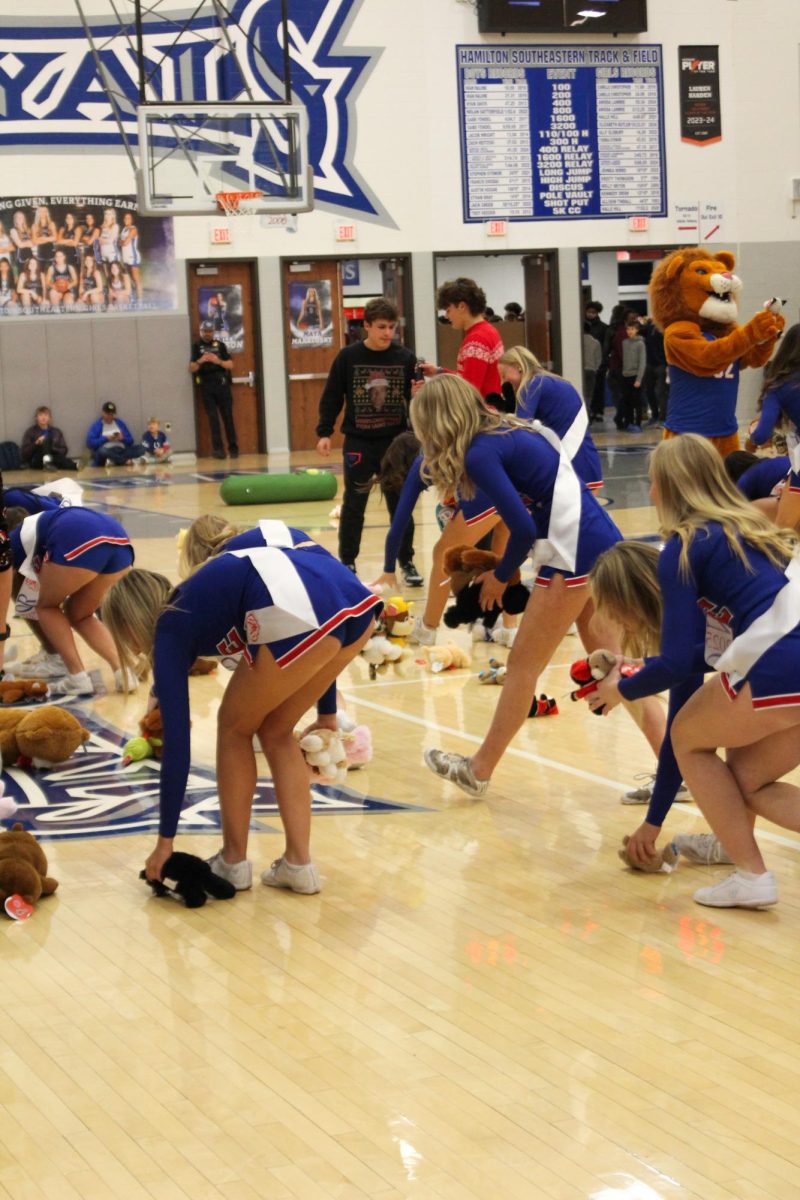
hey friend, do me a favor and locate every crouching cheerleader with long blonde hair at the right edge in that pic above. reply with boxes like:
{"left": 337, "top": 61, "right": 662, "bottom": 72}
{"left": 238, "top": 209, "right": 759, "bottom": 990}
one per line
{"left": 591, "top": 434, "right": 800, "bottom": 908}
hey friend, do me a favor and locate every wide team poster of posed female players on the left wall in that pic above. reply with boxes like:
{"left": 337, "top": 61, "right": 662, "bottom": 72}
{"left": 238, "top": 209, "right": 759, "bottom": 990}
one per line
{"left": 0, "top": 196, "right": 178, "bottom": 317}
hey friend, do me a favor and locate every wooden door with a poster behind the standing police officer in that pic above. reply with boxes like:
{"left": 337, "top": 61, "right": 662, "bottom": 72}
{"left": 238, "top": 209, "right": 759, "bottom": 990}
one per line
{"left": 187, "top": 260, "right": 261, "bottom": 456}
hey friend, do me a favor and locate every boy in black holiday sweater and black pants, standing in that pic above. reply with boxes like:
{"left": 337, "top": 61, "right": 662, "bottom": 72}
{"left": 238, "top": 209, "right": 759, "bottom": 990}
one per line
{"left": 317, "top": 296, "right": 422, "bottom": 587}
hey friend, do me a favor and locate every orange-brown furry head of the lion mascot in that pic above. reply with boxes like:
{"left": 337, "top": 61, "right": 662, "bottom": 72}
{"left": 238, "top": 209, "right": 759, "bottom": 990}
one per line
{"left": 650, "top": 246, "right": 741, "bottom": 332}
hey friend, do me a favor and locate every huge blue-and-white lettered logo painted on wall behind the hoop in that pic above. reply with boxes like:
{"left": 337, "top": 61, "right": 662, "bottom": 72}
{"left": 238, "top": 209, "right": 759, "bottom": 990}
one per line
{"left": 0, "top": 0, "right": 383, "bottom": 216}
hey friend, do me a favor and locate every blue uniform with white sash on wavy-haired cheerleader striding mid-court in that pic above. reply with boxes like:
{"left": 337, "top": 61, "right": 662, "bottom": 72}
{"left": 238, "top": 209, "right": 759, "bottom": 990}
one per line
{"left": 464, "top": 426, "right": 622, "bottom": 587}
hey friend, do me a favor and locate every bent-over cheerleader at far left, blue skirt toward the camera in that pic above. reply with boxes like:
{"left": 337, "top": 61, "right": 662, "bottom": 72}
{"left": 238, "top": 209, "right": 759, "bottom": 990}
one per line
{"left": 11, "top": 508, "right": 138, "bottom": 695}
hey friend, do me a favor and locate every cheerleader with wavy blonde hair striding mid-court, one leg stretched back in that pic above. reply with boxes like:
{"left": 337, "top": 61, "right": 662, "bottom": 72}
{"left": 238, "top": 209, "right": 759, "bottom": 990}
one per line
{"left": 411, "top": 376, "right": 621, "bottom": 796}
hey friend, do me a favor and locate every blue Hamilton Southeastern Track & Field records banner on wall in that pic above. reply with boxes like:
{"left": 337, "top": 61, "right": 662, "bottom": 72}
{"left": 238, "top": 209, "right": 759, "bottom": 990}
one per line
{"left": 456, "top": 44, "right": 667, "bottom": 222}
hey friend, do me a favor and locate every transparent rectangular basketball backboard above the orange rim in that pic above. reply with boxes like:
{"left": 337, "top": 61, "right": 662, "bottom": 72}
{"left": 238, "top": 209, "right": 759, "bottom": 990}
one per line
{"left": 137, "top": 102, "right": 313, "bottom": 216}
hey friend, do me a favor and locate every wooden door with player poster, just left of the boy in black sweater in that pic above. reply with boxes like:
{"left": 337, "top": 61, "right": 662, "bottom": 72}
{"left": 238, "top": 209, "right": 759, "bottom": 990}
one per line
{"left": 283, "top": 259, "right": 344, "bottom": 450}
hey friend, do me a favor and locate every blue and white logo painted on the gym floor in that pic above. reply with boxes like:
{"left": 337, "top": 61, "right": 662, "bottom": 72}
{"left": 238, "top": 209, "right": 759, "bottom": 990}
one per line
{"left": 0, "top": 706, "right": 423, "bottom": 841}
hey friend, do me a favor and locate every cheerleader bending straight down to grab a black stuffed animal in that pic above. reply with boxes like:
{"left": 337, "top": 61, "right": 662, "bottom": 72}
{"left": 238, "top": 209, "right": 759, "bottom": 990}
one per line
{"left": 102, "top": 544, "right": 381, "bottom": 893}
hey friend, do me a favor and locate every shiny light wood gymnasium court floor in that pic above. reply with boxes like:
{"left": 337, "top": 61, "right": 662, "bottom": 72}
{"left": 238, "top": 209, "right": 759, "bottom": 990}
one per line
{"left": 0, "top": 436, "right": 800, "bottom": 1200}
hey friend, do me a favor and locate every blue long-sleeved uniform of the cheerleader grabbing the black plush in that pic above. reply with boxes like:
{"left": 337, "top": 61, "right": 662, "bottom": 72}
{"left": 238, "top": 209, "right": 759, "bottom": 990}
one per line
{"left": 154, "top": 535, "right": 383, "bottom": 838}
